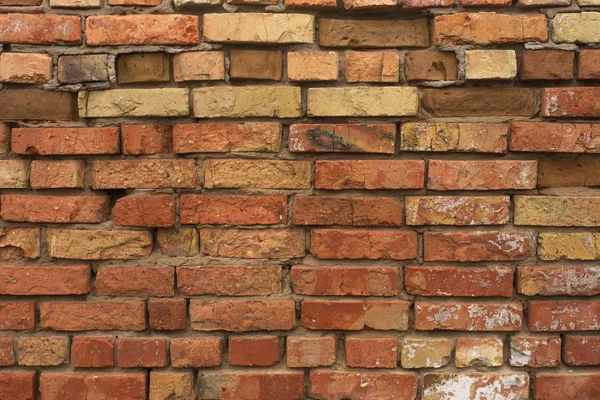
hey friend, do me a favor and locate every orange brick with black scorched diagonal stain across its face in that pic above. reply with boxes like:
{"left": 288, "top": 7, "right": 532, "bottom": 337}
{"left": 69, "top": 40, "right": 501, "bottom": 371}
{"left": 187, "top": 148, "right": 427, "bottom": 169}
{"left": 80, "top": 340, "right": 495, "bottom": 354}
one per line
{"left": 288, "top": 124, "right": 396, "bottom": 154}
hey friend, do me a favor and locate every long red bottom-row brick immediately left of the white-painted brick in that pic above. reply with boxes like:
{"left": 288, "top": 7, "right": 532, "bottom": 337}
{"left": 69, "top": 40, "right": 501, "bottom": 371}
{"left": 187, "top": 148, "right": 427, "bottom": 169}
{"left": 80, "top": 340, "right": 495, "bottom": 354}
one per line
{"left": 309, "top": 370, "right": 418, "bottom": 400}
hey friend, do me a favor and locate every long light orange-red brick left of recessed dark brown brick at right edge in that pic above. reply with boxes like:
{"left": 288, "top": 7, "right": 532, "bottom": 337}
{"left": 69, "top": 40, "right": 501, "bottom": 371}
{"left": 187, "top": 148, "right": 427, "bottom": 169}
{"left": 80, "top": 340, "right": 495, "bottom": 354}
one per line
{"left": 427, "top": 160, "right": 537, "bottom": 191}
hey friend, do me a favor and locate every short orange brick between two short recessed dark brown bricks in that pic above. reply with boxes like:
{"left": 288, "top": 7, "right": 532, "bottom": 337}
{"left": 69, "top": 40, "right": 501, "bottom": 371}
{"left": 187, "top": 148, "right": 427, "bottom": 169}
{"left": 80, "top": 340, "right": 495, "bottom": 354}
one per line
{"left": 173, "top": 51, "right": 225, "bottom": 82}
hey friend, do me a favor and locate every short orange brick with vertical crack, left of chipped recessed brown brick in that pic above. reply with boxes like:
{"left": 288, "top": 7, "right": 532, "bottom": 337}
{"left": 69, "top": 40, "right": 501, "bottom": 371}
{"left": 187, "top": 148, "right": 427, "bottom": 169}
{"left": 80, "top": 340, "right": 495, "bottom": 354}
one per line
{"left": 345, "top": 51, "right": 400, "bottom": 82}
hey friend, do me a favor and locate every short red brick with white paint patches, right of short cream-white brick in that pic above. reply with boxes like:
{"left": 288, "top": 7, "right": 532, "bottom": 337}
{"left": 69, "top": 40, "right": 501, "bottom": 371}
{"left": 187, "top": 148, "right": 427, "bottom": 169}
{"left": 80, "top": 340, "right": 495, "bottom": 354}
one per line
{"left": 508, "top": 336, "right": 561, "bottom": 368}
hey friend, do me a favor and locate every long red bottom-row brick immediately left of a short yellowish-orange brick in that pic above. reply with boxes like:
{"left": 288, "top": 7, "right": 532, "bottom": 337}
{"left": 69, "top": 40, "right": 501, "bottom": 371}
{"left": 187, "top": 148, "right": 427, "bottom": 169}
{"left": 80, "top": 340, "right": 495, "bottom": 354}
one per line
{"left": 40, "top": 372, "right": 146, "bottom": 400}
